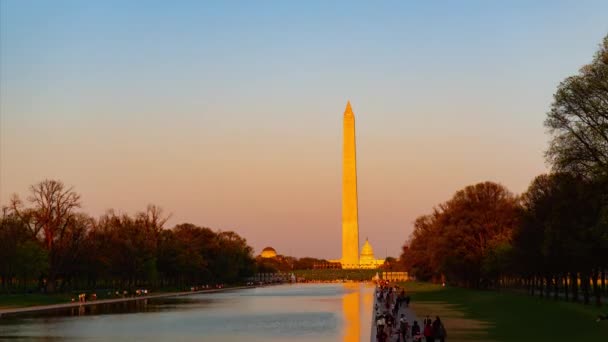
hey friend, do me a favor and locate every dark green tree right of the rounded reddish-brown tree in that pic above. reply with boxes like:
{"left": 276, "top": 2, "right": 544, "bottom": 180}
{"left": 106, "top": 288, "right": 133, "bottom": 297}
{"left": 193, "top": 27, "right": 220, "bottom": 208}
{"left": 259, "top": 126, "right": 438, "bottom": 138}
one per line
{"left": 515, "top": 173, "right": 608, "bottom": 302}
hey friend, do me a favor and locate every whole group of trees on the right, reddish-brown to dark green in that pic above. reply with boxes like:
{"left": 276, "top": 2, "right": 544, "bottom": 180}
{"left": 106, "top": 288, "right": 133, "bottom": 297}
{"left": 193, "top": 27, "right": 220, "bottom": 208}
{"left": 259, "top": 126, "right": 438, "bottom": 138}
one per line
{"left": 400, "top": 36, "right": 608, "bottom": 304}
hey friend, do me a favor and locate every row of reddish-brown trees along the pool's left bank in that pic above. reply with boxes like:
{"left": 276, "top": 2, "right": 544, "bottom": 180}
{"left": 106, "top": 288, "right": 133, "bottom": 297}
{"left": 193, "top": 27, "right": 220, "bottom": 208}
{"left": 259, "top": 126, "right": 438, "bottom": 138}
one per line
{"left": 0, "top": 180, "right": 255, "bottom": 292}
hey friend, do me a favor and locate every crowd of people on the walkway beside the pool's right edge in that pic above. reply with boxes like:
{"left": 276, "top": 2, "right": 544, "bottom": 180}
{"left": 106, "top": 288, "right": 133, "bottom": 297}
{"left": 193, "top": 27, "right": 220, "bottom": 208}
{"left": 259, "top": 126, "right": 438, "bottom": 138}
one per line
{"left": 374, "top": 281, "right": 447, "bottom": 342}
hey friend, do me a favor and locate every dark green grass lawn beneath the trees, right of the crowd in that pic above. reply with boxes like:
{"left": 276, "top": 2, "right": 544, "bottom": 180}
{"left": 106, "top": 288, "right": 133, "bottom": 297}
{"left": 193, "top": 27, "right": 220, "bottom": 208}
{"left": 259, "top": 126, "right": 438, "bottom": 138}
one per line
{"left": 404, "top": 282, "right": 608, "bottom": 342}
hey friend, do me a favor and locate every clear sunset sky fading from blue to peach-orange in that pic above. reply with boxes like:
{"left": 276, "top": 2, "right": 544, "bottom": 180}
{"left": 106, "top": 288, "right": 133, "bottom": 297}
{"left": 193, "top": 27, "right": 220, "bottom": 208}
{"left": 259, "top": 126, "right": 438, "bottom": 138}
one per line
{"left": 0, "top": 0, "right": 608, "bottom": 258}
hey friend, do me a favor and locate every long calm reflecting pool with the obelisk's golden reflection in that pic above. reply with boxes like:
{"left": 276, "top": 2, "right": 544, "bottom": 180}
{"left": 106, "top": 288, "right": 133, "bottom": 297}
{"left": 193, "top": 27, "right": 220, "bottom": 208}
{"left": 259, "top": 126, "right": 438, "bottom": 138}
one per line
{"left": 0, "top": 283, "right": 374, "bottom": 342}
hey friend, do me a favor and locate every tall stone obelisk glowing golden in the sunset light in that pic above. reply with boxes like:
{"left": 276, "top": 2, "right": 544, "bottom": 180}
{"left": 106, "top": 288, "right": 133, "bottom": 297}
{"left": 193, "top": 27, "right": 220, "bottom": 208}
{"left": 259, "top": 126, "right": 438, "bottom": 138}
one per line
{"left": 341, "top": 101, "right": 359, "bottom": 268}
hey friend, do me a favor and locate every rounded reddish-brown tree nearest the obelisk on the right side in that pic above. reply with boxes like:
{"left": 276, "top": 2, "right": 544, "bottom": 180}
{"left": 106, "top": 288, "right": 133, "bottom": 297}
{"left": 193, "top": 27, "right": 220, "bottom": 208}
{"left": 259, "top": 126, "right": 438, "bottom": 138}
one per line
{"left": 401, "top": 182, "right": 519, "bottom": 287}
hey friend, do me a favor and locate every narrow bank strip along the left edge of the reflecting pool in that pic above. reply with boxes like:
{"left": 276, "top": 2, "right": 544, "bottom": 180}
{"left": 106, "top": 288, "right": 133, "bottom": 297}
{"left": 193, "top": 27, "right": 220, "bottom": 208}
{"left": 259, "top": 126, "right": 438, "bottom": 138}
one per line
{"left": 0, "top": 286, "right": 256, "bottom": 319}
